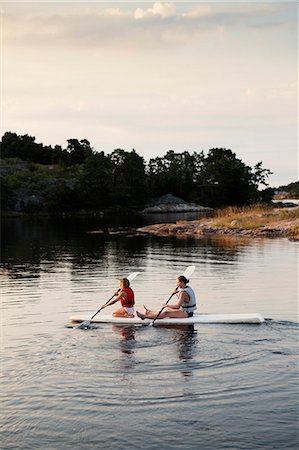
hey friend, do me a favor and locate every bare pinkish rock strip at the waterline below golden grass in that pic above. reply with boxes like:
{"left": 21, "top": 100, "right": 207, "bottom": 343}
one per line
{"left": 138, "top": 210, "right": 299, "bottom": 241}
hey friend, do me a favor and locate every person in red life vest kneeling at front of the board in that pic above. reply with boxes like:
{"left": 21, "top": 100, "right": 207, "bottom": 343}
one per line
{"left": 102, "top": 278, "right": 135, "bottom": 318}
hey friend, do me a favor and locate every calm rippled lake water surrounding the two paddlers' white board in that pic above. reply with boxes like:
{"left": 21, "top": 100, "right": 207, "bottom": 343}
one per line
{"left": 0, "top": 217, "right": 299, "bottom": 450}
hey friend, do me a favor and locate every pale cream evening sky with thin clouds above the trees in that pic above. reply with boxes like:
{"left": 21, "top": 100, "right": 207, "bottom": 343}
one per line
{"left": 1, "top": 1, "right": 298, "bottom": 187}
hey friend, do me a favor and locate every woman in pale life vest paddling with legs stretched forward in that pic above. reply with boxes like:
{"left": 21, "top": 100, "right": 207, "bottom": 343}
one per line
{"left": 136, "top": 275, "right": 197, "bottom": 320}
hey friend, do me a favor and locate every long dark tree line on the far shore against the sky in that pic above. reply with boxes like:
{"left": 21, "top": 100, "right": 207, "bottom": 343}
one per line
{"left": 1, "top": 132, "right": 273, "bottom": 212}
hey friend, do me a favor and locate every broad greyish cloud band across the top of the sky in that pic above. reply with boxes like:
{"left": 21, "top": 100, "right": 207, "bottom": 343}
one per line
{"left": 3, "top": 2, "right": 294, "bottom": 49}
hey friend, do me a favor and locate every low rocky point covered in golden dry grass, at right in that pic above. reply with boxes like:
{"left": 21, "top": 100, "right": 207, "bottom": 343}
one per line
{"left": 140, "top": 205, "right": 299, "bottom": 240}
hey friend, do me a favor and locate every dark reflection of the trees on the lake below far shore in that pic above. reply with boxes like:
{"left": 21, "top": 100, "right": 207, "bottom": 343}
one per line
{"left": 1, "top": 217, "right": 252, "bottom": 277}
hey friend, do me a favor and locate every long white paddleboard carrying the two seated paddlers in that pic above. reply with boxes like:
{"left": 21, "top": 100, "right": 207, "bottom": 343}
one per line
{"left": 70, "top": 313, "right": 265, "bottom": 325}
